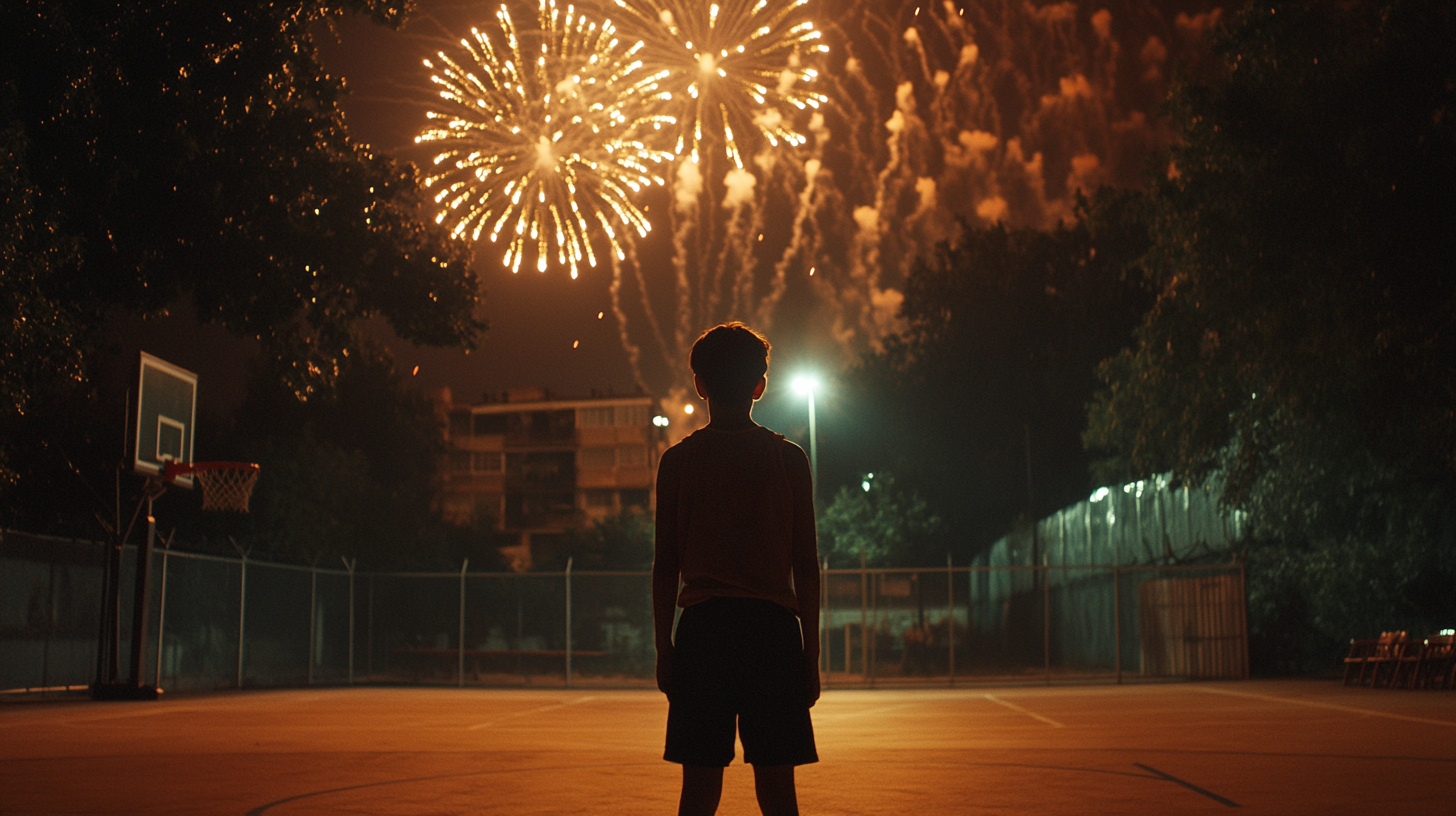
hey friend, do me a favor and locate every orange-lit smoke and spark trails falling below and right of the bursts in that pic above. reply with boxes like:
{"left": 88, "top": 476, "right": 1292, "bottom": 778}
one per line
{"left": 591, "top": 0, "right": 1219, "bottom": 399}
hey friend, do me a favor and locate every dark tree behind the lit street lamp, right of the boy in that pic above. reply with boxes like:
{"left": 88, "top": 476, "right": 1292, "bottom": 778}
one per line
{"left": 826, "top": 189, "right": 1149, "bottom": 560}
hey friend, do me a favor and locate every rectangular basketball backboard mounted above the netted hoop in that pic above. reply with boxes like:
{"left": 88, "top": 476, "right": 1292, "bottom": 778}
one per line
{"left": 134, "top": 351, "right": 197, "bottom": 488}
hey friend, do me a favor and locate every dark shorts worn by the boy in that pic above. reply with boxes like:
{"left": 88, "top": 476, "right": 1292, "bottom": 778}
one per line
{"left": 662, "top": 597, "right": 818, "bottom": 768}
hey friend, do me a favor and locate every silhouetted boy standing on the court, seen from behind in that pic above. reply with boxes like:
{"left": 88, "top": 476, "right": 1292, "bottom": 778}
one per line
{"left": 652, "top": 323, "right": 820, "bottom": 816}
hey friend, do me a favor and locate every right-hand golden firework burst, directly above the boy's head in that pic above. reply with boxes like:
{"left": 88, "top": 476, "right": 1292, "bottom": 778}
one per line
{"left": 614, "top": 0, "right": 828, "bottom": 169}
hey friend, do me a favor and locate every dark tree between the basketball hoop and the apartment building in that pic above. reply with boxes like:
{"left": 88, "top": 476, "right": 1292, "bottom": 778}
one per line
{"left": 176, "top": 346, "right": 501, "bottom": 570}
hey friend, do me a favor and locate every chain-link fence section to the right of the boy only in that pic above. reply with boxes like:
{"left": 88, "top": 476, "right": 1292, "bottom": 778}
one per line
{"left": 821, "top": 565, "right": 1248, "bottom": 686}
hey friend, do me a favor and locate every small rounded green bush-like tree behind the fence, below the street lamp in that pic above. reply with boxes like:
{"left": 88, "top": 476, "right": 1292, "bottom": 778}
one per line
{"left": 818, "top": 471, "right": 946, "bottom": 567}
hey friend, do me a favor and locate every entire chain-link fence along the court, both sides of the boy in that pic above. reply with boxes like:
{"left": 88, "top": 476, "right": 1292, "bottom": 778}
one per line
{"left": 0, "top": 542, "right": 1246, "bottom": 691}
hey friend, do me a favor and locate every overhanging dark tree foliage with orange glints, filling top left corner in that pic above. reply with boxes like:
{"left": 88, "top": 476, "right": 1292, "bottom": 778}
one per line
{"left": 0, "top": 0, "right": 482, "bottom": 395}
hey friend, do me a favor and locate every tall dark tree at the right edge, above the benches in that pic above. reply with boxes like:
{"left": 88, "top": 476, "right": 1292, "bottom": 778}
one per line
{"left": 1086, "top": 0, "right": 1456, "bottom": 664}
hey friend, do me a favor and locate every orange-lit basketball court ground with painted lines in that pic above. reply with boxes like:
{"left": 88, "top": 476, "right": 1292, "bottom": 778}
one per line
{"left": 0, "top": 680, "right": 1456, "bottom": 816}
